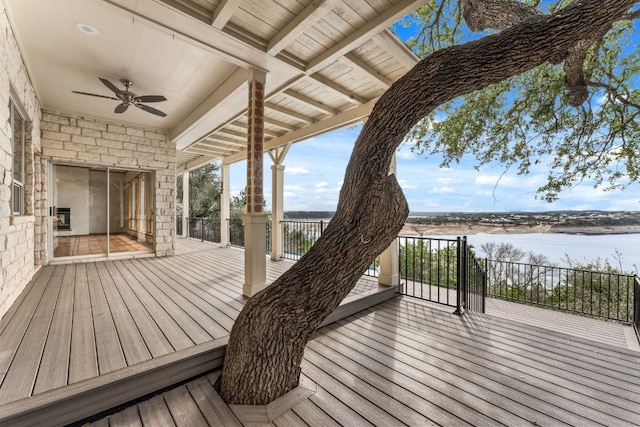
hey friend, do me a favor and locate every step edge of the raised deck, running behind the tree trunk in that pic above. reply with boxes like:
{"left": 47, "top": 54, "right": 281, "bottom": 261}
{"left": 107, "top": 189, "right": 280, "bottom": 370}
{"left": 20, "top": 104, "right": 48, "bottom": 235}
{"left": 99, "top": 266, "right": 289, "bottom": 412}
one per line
{"left": 0, "top": 286, "right": 397, "bottom": 427}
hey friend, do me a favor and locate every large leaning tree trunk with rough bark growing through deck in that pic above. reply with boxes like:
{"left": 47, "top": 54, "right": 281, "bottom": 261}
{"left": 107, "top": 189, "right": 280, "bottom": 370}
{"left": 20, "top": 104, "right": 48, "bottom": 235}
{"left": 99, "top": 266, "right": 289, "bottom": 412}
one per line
{"left": 220, "top": 0, "right": 635, "bottom": 404}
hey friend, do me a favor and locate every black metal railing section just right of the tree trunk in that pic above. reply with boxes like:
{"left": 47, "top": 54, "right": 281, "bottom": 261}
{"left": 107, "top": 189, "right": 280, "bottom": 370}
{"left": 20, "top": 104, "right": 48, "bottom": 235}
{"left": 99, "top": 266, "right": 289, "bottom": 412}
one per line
{"left": 398, "top": 236, "right": 486, "bottom": 314}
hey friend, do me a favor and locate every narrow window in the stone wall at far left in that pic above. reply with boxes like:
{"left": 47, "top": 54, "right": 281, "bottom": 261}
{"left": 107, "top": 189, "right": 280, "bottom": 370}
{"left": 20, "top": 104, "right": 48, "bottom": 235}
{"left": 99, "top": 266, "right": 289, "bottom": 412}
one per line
{"left": 9, "top": 99, "right": 25, "bottom": 215}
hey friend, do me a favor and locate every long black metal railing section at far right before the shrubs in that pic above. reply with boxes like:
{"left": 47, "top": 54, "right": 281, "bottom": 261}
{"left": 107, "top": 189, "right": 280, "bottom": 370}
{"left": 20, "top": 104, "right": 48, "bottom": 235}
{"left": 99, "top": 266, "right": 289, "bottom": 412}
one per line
{"left": 484, "top": 259, "right": 638, "bottom": 323}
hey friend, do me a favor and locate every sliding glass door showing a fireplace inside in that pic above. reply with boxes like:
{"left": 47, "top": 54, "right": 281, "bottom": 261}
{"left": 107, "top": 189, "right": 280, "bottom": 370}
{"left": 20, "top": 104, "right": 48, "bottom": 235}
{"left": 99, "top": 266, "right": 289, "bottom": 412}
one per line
{"left": 49, "top": 164, "right": 154, "bottom": 259}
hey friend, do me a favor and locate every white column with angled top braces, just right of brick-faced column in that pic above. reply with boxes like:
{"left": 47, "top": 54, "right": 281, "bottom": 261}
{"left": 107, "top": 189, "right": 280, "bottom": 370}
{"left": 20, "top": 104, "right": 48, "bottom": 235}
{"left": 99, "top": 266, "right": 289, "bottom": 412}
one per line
{"left": 269, "top": 143, "right": 291, "bottom": 261}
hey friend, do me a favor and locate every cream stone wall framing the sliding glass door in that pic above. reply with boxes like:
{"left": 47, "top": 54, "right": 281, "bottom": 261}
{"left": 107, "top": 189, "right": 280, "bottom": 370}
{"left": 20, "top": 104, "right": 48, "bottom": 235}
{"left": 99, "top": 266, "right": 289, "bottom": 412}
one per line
{"left": 35, "top": 111, "right": 176, "bottom": 264}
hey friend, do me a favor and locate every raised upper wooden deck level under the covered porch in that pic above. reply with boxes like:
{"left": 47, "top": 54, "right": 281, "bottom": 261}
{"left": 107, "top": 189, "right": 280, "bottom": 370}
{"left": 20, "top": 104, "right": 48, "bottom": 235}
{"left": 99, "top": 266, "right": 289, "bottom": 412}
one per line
{"left": 0, "top": 240, "right": 395, "bottom": 425}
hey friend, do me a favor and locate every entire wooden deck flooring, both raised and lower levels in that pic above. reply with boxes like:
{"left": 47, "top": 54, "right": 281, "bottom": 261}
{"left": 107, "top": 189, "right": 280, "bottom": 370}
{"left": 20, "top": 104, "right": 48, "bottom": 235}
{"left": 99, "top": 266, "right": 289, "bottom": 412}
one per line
{"left": 0, "top": 240, "right": 640, "bottom": 426}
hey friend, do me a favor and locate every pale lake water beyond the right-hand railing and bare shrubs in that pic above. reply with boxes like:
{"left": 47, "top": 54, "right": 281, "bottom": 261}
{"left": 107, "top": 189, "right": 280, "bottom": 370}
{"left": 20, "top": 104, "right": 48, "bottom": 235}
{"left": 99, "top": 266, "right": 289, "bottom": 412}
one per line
{"left": 425, "top": 233, "right": 640, "bottom": 273}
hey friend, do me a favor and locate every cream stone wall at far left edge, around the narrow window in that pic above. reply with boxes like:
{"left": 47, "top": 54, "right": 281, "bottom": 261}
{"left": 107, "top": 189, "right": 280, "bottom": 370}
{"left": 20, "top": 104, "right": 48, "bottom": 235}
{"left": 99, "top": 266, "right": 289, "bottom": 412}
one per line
{"left": 0, "top": 0, "right": 40, "bottom": 318}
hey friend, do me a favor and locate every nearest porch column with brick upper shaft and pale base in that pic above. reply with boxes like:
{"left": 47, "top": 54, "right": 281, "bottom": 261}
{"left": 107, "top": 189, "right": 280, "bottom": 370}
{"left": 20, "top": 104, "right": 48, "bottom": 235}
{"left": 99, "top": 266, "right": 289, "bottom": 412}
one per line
{"left": 242, "top": 69, "right": 267, "bottom": 297}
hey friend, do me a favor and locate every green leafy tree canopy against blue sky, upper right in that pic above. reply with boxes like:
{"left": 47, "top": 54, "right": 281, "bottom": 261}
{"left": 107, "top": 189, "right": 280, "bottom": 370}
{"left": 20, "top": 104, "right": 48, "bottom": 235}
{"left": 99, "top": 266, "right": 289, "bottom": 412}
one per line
{"left": 400, "top": 0, "right": 640, "bottom": 201}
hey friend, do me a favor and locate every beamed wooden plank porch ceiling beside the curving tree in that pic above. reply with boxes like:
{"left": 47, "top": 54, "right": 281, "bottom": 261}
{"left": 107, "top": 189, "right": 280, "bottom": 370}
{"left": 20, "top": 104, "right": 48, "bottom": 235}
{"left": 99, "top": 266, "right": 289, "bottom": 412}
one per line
{"left": 160, "top": 0, "right": 424, "bottom": 170}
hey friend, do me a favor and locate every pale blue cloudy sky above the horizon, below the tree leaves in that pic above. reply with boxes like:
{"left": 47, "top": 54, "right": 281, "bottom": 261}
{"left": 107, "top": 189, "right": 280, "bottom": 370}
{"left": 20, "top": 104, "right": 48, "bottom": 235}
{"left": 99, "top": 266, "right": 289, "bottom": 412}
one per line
{"left": 230, "top": 126, "right": 640, "bottom": 212}
